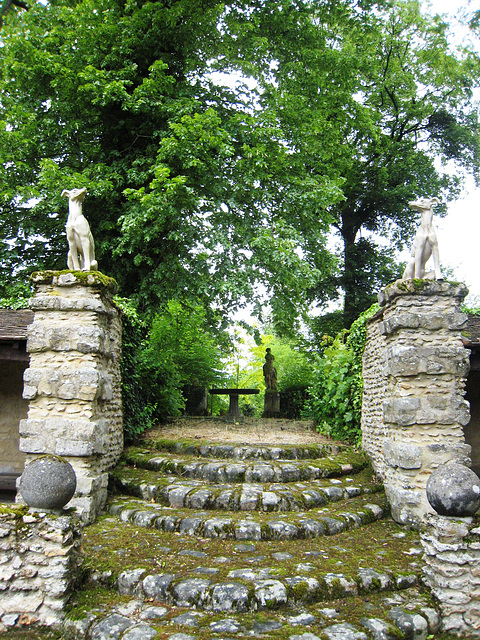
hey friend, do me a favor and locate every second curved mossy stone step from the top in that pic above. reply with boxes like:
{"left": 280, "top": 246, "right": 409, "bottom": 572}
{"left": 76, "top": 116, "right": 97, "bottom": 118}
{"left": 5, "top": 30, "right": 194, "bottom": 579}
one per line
{"left": 123, "top": 450, "right": 368, "bottom": 483}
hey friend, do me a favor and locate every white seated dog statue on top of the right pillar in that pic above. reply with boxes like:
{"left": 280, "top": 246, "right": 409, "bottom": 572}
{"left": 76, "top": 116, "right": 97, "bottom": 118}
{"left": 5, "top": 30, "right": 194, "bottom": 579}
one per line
{"left": 403, "top": 198, "right": 442, "bottom": 280}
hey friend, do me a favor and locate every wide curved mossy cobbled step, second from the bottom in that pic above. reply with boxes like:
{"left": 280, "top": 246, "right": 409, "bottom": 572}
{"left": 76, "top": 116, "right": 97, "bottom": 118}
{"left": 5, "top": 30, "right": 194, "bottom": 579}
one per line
{"left": 117, "top": 567, "right": 419, "bottom": 613}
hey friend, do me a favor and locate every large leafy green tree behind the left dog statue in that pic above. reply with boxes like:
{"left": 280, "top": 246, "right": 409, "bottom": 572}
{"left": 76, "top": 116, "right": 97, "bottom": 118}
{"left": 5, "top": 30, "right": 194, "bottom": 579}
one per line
{"left": 0, "top": 0, "right": 339, "bottom": 328}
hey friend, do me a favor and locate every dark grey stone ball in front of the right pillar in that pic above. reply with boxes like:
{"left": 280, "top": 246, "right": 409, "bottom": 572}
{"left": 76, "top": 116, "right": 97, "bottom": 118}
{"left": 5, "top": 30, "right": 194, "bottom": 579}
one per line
{"left": 427, "top": 462, "right": 480, "bottom": 518}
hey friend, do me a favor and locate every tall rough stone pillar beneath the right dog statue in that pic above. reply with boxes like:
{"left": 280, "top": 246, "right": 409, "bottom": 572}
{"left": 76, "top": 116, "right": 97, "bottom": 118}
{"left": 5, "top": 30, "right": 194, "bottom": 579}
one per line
{"left": 379, "top": 280, "right": 470, "bottom": 525}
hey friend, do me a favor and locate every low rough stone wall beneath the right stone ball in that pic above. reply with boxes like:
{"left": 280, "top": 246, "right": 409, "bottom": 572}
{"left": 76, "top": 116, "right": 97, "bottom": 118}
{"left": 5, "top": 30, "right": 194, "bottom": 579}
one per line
{"left": 422, "top": 514, "right": 480, "bottom": 638}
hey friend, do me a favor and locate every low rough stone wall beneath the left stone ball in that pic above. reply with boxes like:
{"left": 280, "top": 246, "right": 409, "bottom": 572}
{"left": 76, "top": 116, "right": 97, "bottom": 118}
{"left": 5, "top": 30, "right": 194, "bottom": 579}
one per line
{"left": 0, "top": 506, "right": 81, "bottom": 632}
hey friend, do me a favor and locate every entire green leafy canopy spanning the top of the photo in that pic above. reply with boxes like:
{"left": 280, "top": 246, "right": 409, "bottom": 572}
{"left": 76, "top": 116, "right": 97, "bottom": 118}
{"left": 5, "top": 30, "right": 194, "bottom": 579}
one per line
{"left": 0, "top": 0, "right": 480, "bottom": 331}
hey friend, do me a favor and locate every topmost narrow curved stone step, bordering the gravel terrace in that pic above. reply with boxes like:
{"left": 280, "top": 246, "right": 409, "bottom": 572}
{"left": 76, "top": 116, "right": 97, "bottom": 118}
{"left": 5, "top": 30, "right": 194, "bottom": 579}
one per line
{"left": 130, "top": 440, "right": 344, "bottom": 460}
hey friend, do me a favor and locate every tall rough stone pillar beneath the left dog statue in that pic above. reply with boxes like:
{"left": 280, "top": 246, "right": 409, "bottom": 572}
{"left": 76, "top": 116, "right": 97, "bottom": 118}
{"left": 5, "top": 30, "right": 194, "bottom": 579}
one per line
{"left": 20, "top": 271, "right": 123, "bottom": 522}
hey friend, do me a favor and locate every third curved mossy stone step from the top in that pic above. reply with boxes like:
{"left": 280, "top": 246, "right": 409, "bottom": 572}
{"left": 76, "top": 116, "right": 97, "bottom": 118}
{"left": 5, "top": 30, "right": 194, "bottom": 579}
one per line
{"left": 111, "top": 467, "right": 382, "bottom": 512}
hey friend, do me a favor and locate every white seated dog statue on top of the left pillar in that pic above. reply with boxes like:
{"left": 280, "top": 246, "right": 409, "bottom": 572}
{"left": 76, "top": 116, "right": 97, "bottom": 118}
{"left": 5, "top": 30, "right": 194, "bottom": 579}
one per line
{"left": 62, "top": 188, "right": 98, "bottom": 271}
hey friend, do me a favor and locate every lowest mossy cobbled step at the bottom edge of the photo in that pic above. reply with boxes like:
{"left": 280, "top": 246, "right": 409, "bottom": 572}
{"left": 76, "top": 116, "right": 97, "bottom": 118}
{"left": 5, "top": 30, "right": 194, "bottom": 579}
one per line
{"left": 63, "top": 587, "right": 440, "bottom": 640}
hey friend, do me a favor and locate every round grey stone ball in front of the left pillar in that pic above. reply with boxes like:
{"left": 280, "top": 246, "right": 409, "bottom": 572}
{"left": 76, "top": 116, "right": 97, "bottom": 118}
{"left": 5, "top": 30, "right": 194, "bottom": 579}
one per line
{"left": 19, "top": 456, "right": 77, "bottom": 511}
